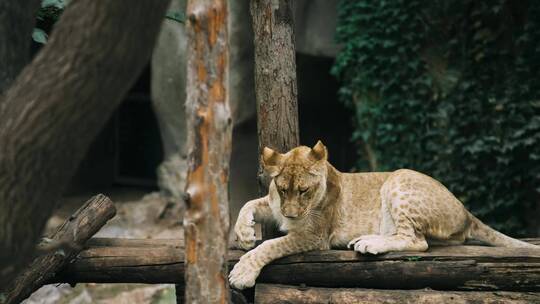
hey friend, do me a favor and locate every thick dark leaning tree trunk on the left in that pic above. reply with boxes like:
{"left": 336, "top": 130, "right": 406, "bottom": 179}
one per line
{"left": 0, "top": 0, "right": 169, "bottom": 286}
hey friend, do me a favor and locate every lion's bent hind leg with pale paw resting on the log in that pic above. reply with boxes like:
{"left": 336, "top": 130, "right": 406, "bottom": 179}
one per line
{"left": 348, "top": 197, "right": 428, "bottom": 254}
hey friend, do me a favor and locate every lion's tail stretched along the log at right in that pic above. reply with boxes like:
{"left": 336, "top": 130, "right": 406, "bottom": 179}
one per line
{"left": 469, "top": 213, "right": 540, "bottom": 249}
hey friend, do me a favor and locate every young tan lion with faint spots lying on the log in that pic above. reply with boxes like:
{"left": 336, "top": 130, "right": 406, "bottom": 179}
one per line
{"left": 229, "top": 141, "right": 536, "bottom": 289}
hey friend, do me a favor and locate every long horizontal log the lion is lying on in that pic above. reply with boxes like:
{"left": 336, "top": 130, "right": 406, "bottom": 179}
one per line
{"left": 52, "top": 239, "right": 540, "bottom": 291}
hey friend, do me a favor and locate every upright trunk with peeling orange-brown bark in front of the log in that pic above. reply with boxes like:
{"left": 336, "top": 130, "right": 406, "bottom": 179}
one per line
{"left": 184, "top": 0, "right": 232, "bottom": 303}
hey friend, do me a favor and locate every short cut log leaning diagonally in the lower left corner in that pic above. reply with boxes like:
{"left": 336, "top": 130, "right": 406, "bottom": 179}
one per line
{"left": 0, "top": 194, "right": 116, "bottom": 304}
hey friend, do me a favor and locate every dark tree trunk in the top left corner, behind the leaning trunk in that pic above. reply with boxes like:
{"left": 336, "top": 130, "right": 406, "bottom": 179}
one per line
{"left": 0, "top": 0, "right": 41, "bottom": 95}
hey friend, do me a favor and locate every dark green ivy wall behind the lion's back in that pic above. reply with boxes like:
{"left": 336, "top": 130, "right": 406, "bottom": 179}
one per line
{"left": 333, "top": 0, "right": 540, "bottom": 235}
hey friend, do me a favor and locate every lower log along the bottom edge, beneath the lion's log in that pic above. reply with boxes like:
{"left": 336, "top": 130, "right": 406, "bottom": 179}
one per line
{"left": 255, "top": 284, "right": 540, "bottom": 304}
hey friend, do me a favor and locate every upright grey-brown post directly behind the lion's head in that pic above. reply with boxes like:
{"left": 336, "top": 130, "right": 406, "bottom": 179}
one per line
{"left": 251, "top": 0, "right": 300, "bottom": 239}
